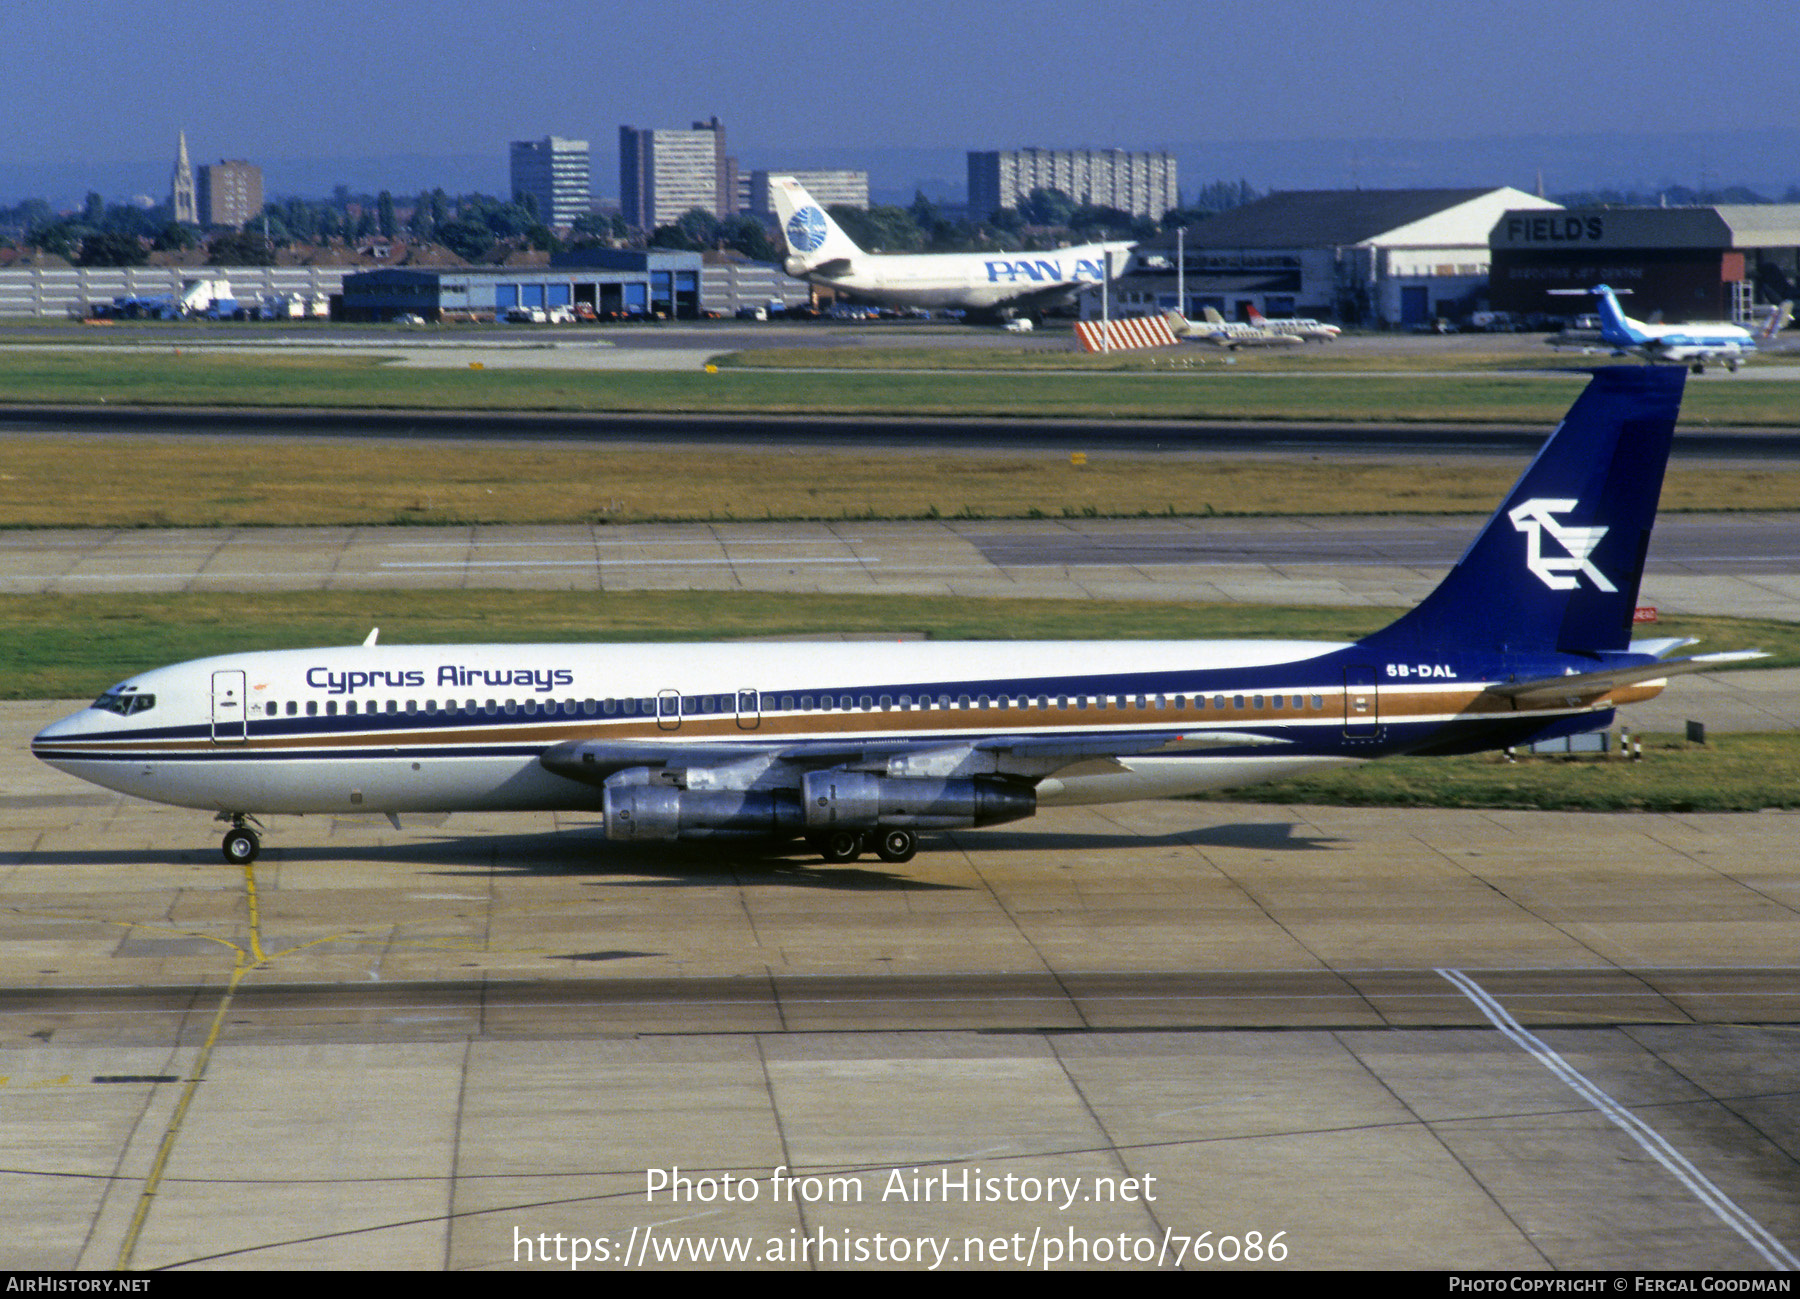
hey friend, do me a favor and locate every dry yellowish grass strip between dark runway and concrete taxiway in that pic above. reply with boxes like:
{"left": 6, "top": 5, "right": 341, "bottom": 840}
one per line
{"left": 0, "top": 437, "right": 1800, "bottom": 527}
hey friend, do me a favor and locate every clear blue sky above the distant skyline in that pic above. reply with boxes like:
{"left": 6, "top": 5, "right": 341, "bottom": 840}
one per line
{"left": 0, "top": 0, "right": 1800, "bottom": 189}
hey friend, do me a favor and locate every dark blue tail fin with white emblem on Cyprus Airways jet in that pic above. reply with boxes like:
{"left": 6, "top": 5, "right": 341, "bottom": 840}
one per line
{"left": 1363, "top": 365, "right": 1687, "bottom": 655}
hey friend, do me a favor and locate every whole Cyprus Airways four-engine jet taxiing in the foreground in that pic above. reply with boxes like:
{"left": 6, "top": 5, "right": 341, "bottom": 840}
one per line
{"left": 32, "top": 367, "right": 1757, "bottom": 862}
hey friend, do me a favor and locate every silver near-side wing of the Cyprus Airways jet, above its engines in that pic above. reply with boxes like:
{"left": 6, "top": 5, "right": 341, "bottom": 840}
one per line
{"left": 538, "top": 730, "right": 1289, "bottom": 784}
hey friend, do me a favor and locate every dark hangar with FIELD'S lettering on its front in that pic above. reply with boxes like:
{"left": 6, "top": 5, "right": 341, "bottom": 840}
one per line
{"left": 1489, "top": 203, "right": 1800, "bottom": 324}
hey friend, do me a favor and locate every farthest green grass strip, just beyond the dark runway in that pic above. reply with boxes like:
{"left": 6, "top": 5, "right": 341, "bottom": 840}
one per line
{"left": 10, "top": 336, "right": 1800, "bottom": 428}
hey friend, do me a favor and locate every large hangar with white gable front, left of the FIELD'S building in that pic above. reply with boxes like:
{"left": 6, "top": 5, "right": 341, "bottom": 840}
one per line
{"left": 1116, "top": 187, "right": 1561, "bottom": 326}
